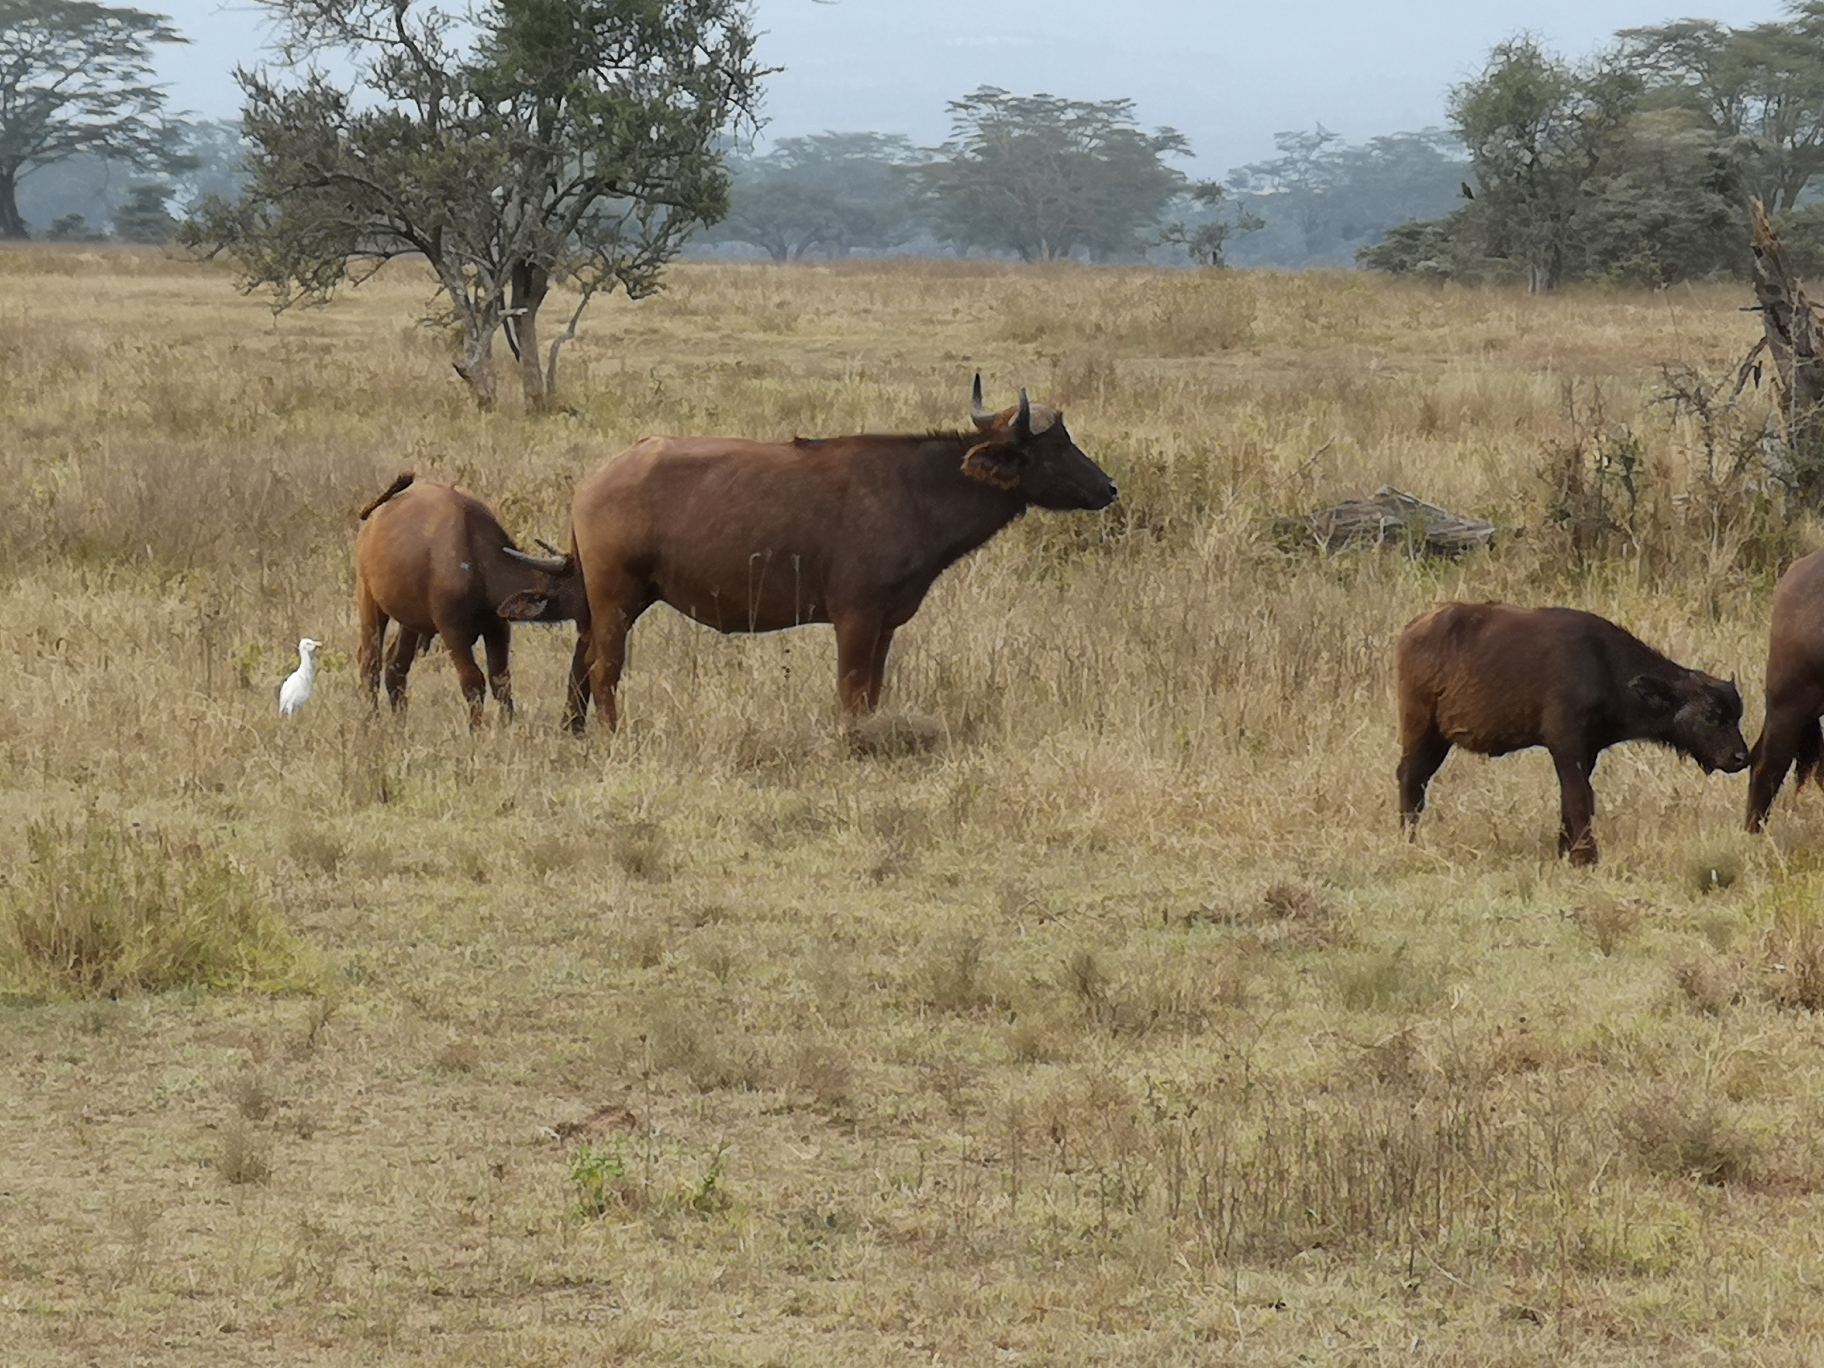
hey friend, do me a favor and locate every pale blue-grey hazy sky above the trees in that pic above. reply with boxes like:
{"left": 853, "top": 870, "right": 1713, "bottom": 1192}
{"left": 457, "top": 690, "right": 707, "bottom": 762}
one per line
{"left": 153, "top": 0, "right": 1782, "bottom": 177}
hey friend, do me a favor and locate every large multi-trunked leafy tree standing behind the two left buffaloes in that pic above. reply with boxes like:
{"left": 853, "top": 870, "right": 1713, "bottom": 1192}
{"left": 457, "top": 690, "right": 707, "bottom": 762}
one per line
{"left": 186, "top": 0, "right": 764, "bottom": 409}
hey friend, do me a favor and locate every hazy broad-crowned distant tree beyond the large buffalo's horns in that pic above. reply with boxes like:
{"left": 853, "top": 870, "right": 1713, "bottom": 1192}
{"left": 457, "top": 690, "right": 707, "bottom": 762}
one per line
{"left": 914, "top": 86, "right": 1191, "bottom": 261}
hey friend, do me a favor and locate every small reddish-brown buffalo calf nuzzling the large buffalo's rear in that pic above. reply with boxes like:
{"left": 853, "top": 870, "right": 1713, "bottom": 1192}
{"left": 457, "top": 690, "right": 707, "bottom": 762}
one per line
{"left": 354, "top": 474, "right": 586, "bottom": 726}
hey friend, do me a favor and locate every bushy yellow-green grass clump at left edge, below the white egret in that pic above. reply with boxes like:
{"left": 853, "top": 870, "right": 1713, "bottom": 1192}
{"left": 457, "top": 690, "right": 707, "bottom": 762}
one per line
{"left": 0, "top": 814, "right": 301, "bottom": 994}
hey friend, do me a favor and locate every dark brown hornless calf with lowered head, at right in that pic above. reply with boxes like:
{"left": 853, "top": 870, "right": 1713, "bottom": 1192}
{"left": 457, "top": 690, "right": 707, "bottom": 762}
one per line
{"left": 1397, "top": 604, "right": 1747, "bottom": 865}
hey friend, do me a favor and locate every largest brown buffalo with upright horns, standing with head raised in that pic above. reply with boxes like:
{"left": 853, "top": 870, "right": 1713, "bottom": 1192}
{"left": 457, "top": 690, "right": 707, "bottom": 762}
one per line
{"left": 528, "top": 376, "right": 1114, "bottom": 740}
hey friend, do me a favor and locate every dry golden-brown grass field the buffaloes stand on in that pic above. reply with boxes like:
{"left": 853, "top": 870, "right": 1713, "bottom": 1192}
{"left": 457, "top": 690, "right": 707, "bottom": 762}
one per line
{"left": 10, "top": 248, "right": 1824, "bottom": 1368}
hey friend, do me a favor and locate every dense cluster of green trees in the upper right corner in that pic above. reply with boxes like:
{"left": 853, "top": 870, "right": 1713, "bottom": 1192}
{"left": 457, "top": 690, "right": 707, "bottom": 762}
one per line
{"left": 1359, "top": 0, "right": 1824, "bottom": 290}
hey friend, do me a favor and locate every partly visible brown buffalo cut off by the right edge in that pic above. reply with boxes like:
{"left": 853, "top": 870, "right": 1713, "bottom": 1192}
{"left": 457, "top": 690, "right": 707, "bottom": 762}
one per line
{"left": 1747, "top": 551, "right": 1824, "bottom": 832}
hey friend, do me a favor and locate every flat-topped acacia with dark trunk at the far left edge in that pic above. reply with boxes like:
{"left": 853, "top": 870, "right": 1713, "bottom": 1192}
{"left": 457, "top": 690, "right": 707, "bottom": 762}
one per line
{"left": 0, "top": 0, "right": 186, "bottom": 237}
